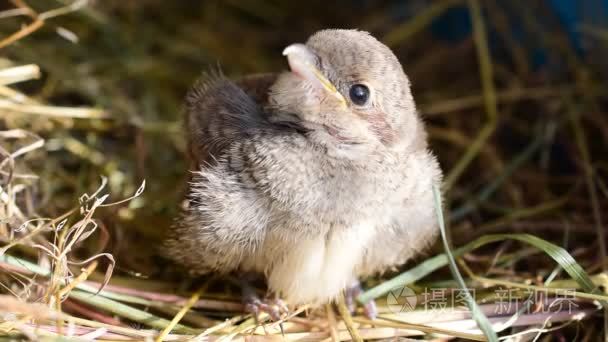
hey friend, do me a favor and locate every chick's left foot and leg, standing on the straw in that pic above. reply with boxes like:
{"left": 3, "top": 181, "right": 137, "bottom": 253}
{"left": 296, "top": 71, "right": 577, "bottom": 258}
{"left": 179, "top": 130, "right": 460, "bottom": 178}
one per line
{"left": 241, "top": 275, "right": 289, "bottom": 321}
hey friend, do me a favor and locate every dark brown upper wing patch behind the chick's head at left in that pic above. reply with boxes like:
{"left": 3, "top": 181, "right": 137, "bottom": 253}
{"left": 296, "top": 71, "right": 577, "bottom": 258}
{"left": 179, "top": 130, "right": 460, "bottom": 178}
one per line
{"left": 185, "top": 73, "right": 276, "bottom": 169}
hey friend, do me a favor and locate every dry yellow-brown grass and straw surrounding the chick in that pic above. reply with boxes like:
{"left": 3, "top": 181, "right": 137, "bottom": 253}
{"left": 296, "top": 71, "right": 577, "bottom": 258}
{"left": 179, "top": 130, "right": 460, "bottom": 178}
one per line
{"left": 0, "top": 0, "right": 608, "bottom": 341}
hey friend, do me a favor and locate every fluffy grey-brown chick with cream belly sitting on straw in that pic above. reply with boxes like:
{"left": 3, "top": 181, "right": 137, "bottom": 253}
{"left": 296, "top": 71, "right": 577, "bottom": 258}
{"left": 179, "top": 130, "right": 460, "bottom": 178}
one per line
{"left": 167, "top": 30, "right": 442, "bottom": 314}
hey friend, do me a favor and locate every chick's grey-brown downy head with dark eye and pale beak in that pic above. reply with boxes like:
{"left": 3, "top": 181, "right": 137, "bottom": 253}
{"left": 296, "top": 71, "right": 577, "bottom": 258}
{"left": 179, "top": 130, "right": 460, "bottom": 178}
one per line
{"left": 269, "top": 30, "right": 418, "bottom": 157}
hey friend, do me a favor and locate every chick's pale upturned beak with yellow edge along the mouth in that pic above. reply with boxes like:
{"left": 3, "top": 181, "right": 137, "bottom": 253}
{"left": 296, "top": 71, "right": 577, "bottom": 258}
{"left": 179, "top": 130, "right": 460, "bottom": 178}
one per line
{"left": 283, "top": 44, "right": 346, "bottom": 106}
